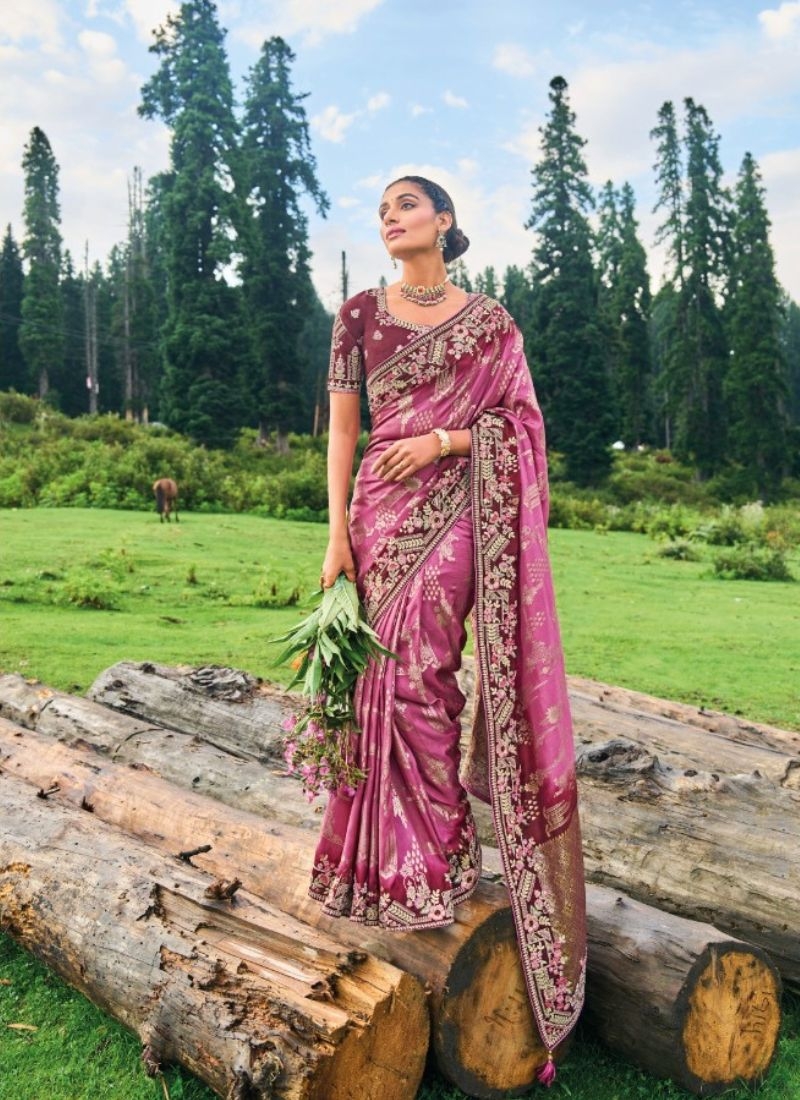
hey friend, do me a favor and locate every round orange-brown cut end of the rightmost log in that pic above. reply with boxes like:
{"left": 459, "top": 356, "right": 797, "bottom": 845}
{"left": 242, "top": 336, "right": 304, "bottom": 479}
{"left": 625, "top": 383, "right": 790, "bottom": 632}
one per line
{"left": 682, "top": 945, "right": 780, "bottom": 1096}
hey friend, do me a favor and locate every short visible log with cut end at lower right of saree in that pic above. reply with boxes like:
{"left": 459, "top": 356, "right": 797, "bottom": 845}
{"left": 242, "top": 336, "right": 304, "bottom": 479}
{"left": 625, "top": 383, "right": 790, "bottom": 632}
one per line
{"left": 585, "top": 886, "right": 780, "bottom": 1096}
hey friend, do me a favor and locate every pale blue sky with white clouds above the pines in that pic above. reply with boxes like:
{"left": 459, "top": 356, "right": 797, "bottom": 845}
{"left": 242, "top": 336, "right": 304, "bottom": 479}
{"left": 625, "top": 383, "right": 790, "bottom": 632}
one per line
{"left": 0, "top": 0, "right": 800, "bottom": 309}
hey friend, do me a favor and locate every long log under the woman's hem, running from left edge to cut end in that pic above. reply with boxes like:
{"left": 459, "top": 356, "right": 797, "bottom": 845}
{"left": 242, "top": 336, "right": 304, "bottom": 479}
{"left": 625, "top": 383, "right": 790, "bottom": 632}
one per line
{"left": 0, "top": 712, "right": 546, "bottom": 1100}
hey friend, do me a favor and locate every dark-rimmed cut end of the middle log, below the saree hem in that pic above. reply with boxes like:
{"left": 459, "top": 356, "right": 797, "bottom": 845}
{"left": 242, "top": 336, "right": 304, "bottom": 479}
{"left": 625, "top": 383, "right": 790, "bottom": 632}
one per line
{"left": 431, "top": 909, "right": 547, "bottom": 1100}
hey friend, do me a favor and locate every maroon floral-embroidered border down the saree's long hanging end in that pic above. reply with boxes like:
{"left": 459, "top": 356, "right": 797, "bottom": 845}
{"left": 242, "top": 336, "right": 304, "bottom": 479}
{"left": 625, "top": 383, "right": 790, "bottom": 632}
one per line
{"left": 472, "top": 413, "right": 585, "bottom": 1051}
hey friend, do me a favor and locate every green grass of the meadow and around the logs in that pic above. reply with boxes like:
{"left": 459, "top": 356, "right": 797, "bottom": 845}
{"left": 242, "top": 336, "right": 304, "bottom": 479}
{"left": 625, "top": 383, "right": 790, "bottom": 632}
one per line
{"left": 0, "top": 509, "right": 800, "bottom": 1100}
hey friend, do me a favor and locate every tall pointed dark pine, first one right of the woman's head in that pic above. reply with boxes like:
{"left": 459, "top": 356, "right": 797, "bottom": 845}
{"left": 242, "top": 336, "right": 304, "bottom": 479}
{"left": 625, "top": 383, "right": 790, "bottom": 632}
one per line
{"left": 526, "top": 77, "right": 613, "bottom": 485}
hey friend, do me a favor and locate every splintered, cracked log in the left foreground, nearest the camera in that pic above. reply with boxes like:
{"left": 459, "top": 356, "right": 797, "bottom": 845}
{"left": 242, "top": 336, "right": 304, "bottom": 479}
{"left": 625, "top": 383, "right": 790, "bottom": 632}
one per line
{"left": 0, "top": 773, "right": 428, "bottom": 1100}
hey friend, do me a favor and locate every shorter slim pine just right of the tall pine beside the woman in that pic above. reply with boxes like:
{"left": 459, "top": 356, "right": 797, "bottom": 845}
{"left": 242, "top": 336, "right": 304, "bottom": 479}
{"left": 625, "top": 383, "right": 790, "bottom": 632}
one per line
{"left": 598, "top": 183, "right": 653, "bottom": 447}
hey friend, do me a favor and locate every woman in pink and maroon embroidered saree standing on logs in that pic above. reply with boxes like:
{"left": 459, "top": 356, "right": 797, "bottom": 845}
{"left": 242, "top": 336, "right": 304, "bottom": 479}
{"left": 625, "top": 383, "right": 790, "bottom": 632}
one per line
{"left": 310, "top": 176, "right": 585, "bottom": 1080}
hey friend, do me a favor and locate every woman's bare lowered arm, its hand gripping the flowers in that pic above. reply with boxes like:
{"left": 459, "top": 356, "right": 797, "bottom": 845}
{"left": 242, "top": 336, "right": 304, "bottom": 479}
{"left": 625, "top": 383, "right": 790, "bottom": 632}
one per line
{"left": 320, "top": 392, "right": 361, "bottom": 589}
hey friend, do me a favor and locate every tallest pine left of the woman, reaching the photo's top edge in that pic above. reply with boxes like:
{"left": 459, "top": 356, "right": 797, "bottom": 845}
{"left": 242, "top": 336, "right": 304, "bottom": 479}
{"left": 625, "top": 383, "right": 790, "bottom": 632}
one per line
{"left": 139, "top": 0, "right": 246, "bottom": 447}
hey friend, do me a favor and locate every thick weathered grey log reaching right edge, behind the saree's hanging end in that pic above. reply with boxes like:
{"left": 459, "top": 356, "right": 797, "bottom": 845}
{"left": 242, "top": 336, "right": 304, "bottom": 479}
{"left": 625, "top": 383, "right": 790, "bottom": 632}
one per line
{"left": 578, "top": 739, "right": 800, "bottom": 987}
